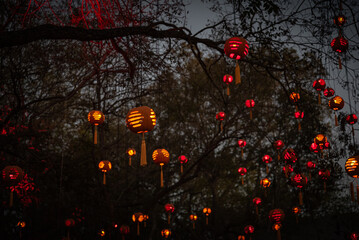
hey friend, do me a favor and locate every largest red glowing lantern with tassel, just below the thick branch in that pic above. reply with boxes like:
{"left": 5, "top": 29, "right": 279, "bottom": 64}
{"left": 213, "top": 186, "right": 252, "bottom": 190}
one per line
{"left": 224, "top": 37, "right": 249, "bottom": 84}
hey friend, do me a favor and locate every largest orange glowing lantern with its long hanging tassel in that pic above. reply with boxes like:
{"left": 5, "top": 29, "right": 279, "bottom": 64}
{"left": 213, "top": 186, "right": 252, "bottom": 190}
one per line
{"left": 126, "top": 106, "right": 156, "bottom": 166}
